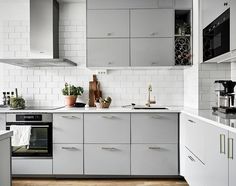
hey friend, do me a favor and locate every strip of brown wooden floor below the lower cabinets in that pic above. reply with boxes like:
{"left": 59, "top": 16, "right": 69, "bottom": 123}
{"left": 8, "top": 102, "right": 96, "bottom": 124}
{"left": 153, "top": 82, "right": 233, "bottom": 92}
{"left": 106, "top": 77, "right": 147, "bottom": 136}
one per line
{"left": 12, "top": 179, "right": 188, "bottom": 186}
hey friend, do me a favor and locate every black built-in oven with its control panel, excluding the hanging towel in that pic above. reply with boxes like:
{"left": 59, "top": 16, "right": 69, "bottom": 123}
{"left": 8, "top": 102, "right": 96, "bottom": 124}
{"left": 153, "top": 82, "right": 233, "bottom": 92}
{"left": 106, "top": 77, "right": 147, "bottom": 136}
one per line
{"left": 6, "top": 113, "right": 52, "bottom": 157}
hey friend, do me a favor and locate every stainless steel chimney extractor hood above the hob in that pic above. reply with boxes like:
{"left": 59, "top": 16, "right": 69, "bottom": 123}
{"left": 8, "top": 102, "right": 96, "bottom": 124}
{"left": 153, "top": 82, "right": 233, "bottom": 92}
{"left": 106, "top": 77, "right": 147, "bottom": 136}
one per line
{"left": 0, "top": 0, "right": 77, "bottom": 67}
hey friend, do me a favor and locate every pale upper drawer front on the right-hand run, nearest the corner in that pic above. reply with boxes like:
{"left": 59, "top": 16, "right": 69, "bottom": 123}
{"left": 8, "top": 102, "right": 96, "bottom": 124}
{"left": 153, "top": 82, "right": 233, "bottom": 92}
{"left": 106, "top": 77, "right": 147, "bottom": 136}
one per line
{"left": 181, "top": 114, "right": 206, "bottom": 162}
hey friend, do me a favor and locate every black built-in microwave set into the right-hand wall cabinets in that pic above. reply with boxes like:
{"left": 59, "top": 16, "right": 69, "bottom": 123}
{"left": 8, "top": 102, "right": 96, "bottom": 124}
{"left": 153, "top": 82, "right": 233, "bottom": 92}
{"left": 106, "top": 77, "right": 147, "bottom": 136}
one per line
{"left": 203, "top": 8, "right": 230, "bottom": 62}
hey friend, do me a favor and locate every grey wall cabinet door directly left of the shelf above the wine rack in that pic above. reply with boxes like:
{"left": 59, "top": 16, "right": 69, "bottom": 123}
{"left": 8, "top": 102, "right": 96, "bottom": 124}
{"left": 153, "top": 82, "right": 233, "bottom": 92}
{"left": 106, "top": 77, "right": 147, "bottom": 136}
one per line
{"left": 130, "top": 9, "right": 174, "bottom": 37}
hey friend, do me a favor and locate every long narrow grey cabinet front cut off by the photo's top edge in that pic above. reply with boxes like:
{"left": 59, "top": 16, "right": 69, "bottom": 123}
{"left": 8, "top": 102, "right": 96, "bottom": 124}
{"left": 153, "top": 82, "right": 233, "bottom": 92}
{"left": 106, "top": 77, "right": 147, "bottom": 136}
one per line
{"left": 87, "top": 0, "right": 158, "bottom": 9}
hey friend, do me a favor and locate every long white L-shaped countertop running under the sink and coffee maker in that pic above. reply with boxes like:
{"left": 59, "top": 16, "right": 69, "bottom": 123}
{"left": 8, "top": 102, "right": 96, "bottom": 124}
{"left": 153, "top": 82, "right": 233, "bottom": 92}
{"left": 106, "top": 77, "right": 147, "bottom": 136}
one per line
{"left": 0, "top": 107, "right": 236, "bottom": 133}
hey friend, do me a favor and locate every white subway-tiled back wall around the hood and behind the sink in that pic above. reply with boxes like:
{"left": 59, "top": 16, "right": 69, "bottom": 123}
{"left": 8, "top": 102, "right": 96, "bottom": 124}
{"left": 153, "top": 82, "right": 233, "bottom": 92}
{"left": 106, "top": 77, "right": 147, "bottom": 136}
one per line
{"left": 0, "top": 0, "right": 184, "bottom": 106}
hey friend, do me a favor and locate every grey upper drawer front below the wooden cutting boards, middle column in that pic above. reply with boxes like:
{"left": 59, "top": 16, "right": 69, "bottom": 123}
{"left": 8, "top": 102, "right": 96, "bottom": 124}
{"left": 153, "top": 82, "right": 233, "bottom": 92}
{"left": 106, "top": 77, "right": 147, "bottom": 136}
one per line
{"left": 84, "top": 113, "right": 130, "bottom": 143}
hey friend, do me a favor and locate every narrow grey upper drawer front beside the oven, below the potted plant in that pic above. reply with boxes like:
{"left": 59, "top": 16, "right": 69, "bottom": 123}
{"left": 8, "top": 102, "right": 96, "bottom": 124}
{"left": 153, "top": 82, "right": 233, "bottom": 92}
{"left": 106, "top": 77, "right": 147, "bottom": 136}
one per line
{"left": 53, "top": 114, "right": 83, "bottom": 143}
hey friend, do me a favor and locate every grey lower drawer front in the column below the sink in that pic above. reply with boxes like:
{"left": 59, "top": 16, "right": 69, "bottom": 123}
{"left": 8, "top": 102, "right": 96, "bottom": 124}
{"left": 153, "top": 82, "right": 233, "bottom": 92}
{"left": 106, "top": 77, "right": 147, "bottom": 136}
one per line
{"left": 131, "top": 144, "right": 178, "bottom": 175}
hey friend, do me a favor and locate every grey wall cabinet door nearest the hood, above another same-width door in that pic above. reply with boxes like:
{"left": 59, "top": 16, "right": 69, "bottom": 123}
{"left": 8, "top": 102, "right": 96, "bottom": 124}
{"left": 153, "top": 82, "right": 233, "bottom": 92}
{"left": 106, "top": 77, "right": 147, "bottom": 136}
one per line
{"left": 87, "top": 10, "right": 129, "bottom": 38}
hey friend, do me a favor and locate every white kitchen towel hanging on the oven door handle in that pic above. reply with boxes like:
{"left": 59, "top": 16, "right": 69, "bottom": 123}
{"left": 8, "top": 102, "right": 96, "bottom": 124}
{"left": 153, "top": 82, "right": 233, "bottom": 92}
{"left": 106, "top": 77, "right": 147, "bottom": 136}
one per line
{"left": 10, "top": 125, "right": 31, "bottom": 147}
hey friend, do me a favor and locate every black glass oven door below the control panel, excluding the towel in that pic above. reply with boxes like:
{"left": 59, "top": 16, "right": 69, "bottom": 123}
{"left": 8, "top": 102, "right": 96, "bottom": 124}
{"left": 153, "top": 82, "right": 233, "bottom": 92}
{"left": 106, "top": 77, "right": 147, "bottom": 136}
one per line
{"left": 6, "top": 122, "right": 52, "bottom": 157}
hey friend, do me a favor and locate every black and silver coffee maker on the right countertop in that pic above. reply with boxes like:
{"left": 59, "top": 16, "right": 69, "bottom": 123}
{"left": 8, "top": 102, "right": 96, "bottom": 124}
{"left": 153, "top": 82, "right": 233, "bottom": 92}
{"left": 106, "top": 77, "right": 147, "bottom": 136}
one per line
{"left": 213, "top": 80, "right": 236, "bottom": 114}
